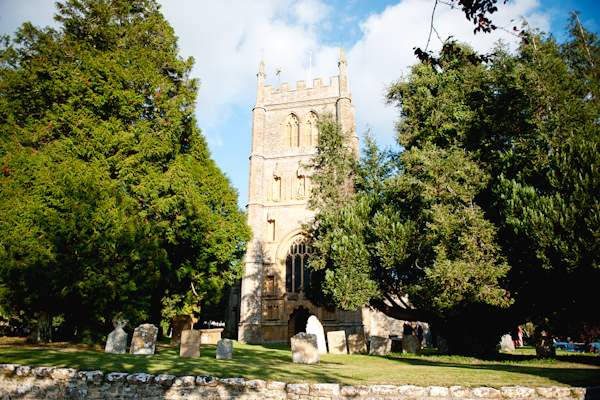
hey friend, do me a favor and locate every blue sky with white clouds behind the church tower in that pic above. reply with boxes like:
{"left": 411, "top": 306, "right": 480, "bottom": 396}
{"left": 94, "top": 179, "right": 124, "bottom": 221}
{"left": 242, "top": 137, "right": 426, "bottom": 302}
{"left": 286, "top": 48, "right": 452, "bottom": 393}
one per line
{"left": 0, "top": 0, "right": 600, "bottom": 207}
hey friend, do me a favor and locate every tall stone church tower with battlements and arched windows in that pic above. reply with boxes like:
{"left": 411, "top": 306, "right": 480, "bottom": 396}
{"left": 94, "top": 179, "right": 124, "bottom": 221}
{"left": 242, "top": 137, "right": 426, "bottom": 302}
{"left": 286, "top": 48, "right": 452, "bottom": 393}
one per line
{"left": 238, "top": 48, "right": 363, "bottom": 344}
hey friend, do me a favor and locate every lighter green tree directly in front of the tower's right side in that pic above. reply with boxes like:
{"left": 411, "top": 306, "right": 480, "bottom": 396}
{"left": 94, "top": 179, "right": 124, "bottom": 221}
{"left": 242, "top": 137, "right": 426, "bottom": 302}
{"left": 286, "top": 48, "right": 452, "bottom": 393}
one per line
{"left": 308, "top": 115, "right": 510, "bottom": 354}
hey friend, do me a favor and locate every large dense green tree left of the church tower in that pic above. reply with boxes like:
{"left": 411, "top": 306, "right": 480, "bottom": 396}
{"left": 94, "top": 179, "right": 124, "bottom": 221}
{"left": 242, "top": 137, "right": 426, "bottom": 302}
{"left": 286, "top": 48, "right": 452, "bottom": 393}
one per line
{"left": 0, "top": 0, "right": 249, "bottom": 339}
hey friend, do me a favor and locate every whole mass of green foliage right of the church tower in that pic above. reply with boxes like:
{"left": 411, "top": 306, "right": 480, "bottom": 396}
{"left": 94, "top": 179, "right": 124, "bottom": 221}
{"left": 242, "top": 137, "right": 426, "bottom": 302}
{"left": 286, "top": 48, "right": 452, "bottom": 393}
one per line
{"left": 311, "top": 13, "right": 600, "bottom": 353}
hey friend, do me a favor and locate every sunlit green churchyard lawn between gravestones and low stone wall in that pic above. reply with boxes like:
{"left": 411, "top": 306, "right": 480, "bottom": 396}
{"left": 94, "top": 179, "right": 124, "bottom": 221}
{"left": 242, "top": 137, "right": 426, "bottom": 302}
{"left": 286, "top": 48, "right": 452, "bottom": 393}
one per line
{"left": 0, "top": 338, "right": 600, "bottom": 388}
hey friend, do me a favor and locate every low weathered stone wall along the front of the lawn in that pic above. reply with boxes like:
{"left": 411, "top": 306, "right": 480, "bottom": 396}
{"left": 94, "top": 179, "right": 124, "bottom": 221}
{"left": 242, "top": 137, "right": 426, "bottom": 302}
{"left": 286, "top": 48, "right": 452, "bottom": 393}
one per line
{"left": 0, "top": 364, "right": 600, "bottom": 400}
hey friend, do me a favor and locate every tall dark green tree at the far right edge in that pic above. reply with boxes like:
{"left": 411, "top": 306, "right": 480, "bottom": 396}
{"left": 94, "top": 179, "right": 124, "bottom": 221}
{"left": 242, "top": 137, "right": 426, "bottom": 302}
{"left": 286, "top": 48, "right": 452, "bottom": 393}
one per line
{"left": 388, "top": 19, "right": 600, "bottom": 350}
